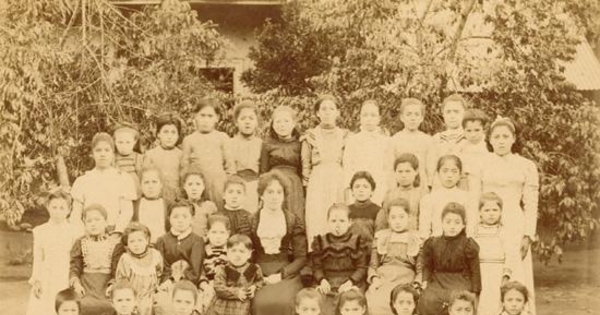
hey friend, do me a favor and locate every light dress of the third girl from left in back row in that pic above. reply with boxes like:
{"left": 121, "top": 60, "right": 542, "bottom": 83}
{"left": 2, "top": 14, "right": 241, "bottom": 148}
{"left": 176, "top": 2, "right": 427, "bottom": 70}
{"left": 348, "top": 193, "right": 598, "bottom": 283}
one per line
{"left": 144, "top": 145, "right": 183, "bottom": 201}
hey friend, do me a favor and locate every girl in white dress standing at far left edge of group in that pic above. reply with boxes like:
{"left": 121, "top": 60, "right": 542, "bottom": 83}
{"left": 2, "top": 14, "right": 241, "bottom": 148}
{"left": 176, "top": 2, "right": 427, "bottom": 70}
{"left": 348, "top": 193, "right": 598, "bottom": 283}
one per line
{"left": 27, "top": 191, "right": 79, "bottom": 315}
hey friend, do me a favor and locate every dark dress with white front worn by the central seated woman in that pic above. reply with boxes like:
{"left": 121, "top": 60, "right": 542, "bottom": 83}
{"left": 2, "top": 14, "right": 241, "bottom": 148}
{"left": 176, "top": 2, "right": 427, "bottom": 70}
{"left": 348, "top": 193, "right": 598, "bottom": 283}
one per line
{"left": 252, "top": 210, "right": 307, "bottom": 315}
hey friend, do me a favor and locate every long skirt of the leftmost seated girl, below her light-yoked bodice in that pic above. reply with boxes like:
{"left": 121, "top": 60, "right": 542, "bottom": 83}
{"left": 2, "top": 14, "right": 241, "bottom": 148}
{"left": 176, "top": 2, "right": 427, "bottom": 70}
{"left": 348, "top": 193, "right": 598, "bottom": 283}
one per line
{"left": 81, "top": 273, "right": 113, "bottom": 315}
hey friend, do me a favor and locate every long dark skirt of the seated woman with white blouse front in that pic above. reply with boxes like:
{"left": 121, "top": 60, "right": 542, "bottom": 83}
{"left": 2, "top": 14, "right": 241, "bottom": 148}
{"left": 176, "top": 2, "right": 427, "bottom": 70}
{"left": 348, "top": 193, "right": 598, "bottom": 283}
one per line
{"left": 252, "top": 260, "right": 302, "bottom": 315}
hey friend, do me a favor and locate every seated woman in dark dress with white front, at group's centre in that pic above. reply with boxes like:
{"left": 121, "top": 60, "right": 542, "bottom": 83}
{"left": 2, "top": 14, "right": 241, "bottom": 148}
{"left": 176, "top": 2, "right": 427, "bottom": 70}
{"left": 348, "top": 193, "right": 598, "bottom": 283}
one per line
{"left": 252, "top": 173, "right": 307, "bottom": 315}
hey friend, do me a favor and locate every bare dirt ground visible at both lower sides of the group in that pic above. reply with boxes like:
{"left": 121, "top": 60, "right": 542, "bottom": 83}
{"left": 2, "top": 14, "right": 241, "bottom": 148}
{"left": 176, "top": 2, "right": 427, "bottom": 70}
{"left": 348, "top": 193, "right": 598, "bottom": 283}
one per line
{"left": 0, "top": 231, "right": 600, "bottom": 315}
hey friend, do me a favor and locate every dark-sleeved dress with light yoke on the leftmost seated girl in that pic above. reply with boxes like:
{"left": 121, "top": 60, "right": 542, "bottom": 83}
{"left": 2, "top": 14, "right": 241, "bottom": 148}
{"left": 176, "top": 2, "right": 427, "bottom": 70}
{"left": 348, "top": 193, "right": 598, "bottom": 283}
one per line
{"left": 69, "top": 234, "right": 123, "bottom": 315}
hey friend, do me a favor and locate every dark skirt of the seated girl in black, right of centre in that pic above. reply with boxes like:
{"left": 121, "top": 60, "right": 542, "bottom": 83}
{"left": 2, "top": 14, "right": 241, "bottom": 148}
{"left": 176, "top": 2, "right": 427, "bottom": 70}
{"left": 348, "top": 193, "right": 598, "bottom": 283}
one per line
{"left": 419, "top": 273, "right": 471, "bottom": 315}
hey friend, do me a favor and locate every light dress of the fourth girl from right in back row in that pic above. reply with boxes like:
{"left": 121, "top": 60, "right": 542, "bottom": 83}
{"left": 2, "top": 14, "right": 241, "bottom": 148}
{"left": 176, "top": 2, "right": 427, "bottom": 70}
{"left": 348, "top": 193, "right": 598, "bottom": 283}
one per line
{"left": 391, "top": 130, "right": 437, "bottom": 190}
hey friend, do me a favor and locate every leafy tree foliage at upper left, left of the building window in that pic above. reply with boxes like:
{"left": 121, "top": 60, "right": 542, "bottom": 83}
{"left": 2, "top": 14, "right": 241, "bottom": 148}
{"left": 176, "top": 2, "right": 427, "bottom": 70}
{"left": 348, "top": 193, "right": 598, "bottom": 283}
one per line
{"left": 0, "top": 0, "right": 226, "bottom": 224}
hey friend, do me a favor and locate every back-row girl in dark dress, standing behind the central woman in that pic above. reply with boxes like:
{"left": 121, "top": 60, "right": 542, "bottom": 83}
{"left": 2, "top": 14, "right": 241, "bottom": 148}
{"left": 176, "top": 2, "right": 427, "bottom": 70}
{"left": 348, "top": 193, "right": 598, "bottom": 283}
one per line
{"left": 260, "top": 106, "right": 304, "bottom": 220}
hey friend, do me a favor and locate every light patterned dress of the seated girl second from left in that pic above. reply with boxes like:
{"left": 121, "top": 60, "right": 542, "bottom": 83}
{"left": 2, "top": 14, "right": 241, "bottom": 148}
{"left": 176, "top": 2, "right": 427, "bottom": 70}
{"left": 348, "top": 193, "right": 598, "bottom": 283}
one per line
{"left": 115, "top": 248, "right": 163, "bottom": 315}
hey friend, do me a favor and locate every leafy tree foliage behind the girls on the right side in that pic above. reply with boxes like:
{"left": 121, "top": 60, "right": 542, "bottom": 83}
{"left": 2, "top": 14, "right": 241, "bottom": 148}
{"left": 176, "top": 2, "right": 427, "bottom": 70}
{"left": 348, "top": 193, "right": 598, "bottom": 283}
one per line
{"left": 245, "top": 0, "right": 600, "bottom": 261}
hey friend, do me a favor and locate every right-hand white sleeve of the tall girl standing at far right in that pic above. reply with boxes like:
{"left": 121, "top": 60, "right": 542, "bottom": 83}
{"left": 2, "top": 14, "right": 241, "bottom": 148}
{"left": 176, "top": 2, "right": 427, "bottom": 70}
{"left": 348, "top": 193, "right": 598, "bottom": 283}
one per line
{"left": 523, "top": 158, "right": 540, "bottom": 240}
